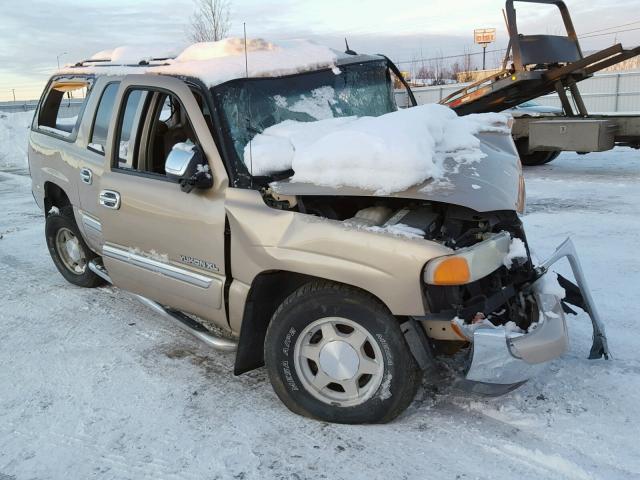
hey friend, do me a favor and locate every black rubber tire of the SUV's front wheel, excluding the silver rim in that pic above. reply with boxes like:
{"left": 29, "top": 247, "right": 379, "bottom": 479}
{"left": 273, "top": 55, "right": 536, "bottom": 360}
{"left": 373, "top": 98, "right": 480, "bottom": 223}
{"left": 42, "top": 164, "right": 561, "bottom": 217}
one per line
{"left": 264, "top": 281, "right": 422, "bottom": 424}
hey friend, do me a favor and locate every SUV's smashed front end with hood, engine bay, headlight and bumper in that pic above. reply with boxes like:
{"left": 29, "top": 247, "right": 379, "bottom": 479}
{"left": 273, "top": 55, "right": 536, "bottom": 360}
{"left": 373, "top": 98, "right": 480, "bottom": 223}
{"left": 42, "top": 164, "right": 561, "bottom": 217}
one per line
{"left": 265, "top": 126, "right": 609, "bottom": 395}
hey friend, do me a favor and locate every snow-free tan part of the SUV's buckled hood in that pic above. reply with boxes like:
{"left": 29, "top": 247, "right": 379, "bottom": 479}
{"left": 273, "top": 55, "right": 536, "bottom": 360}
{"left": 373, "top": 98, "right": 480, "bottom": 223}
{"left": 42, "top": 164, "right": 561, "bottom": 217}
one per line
{"left": 270, "top": 132, "right": 522, "bottom": 212}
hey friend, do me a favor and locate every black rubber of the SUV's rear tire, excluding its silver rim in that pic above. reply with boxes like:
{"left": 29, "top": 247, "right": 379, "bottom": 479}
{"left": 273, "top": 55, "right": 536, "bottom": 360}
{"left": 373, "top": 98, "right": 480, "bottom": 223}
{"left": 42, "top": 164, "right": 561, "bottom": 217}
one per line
{"left": 45, "top": 207, "right": 105, "bottom": 288}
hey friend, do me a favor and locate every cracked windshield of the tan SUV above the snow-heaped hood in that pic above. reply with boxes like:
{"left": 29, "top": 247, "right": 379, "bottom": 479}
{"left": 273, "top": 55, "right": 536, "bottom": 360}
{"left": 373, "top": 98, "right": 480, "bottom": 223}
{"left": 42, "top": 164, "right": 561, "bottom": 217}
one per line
{"left": 212, "top": 60, "right": 397, "bottom": 186}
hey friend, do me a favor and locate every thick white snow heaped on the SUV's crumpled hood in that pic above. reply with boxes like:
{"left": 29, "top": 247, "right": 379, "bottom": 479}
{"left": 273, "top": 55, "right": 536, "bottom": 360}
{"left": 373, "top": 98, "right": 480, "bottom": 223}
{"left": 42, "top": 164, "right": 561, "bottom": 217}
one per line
{"left": 244, "top": 105, "right": 509, "bottom": 195}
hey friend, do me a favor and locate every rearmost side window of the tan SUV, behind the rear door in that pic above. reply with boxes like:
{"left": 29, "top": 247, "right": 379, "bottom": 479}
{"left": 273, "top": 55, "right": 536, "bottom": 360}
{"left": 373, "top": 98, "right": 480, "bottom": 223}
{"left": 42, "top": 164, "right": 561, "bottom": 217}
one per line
{"left": 38, "top": 80, "right": 90, "bottom": 137}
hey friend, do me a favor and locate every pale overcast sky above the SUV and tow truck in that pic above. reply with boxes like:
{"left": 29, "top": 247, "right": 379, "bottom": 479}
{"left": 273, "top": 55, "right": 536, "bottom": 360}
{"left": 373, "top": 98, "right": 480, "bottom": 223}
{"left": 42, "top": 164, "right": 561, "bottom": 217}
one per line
{"left": 0, "top": 0, "right": 640, "bottom": 101}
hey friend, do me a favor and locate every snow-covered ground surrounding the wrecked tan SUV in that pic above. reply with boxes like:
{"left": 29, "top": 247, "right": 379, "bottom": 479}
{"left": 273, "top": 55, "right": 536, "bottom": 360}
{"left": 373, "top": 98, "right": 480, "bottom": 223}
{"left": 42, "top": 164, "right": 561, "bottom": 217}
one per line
{"left": 0, "top": 111, "right": 640, "bottom": 480}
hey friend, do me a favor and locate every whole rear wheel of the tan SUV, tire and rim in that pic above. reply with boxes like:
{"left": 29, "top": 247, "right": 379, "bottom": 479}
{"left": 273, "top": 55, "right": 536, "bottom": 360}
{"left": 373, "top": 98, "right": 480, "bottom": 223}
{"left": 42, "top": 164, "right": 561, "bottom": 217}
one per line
{"left": 45, "top": 207, "right": 104, "bottom": 288}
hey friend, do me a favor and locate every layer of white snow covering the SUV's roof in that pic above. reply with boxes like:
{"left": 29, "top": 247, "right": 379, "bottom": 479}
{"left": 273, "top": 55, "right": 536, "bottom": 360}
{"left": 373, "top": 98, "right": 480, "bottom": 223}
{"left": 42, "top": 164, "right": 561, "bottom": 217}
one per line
{"left": 58, "top": 38, "right": 364, "bottom": 87}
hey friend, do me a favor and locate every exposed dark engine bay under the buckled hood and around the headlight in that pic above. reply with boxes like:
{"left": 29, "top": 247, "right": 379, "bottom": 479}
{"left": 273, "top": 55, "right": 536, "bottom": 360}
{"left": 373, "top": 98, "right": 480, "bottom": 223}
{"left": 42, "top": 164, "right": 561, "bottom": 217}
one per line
{"left": 264, "top": 189, "right": 538, "bottom": 340}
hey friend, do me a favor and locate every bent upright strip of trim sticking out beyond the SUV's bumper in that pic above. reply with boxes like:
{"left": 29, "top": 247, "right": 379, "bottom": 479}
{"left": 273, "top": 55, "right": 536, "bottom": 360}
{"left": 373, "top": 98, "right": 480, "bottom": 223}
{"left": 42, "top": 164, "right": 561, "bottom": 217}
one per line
{"left": 537, "top": 238, "right": 611, "bottom": 359}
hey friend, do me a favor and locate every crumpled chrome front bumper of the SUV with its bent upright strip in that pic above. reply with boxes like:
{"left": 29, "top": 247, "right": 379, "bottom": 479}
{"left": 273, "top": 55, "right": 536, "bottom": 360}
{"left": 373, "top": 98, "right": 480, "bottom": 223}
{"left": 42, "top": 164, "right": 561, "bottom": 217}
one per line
{"left": 460, "top": 239, "right": 609, "bottom": 395}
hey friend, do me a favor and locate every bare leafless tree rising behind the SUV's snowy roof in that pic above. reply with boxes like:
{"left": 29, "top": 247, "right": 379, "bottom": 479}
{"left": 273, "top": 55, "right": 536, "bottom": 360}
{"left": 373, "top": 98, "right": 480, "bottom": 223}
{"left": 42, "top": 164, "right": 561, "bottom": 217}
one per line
{"left": 187, "top": 0, "right": 231, "bottom": 42}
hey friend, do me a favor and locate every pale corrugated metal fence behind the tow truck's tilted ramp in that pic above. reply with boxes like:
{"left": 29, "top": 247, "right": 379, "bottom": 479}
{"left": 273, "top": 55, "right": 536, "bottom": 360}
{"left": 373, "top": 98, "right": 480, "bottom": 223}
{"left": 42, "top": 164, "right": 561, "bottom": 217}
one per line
{"left": 396, "top": 71, "right": 640, "bottom": 113}
